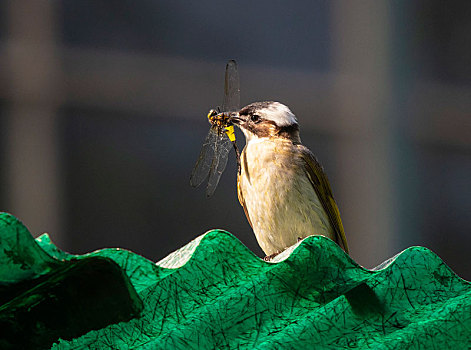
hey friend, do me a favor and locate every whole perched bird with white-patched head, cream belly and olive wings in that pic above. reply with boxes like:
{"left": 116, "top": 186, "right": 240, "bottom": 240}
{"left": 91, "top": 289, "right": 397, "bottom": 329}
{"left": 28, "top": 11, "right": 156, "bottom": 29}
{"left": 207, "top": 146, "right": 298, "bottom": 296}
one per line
{"left": 231, "top": 101, "right": 348, "bottom": 261}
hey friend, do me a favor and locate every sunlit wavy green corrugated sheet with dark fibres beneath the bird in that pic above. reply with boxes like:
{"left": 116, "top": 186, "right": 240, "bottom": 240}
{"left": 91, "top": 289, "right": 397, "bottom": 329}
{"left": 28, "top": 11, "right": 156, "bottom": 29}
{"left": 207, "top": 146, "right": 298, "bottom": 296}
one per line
{"left": 1, "top": 212, "right": 471, "bottom": 349}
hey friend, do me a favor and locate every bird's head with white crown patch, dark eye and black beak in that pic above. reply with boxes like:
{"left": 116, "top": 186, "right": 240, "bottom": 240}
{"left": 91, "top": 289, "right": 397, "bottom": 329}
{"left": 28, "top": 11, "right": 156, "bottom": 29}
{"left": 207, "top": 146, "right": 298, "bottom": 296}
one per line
{"left": 231, "top": 101, "right": 301, "bottom": 143}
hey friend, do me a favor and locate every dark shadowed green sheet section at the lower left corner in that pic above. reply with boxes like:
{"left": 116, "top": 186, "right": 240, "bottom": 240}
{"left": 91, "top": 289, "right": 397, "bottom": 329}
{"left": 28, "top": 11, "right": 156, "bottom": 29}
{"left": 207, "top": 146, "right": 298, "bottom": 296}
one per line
{"left": 0, "top": 213, "right": 142, "bottom": 350}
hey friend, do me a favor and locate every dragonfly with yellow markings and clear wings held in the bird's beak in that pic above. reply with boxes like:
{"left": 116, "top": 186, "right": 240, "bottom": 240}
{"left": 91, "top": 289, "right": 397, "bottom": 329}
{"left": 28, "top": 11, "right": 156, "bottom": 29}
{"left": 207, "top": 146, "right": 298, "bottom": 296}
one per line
{"left": 190, "top": 60, "right": 240, "bottom": 197}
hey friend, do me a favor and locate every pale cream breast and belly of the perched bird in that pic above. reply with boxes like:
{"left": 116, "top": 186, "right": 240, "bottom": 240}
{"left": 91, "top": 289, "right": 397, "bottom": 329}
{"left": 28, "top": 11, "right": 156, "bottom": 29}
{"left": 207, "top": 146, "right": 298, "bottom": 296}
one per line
{"left": 239, "top": 141, "right": 336, "bottom": 254}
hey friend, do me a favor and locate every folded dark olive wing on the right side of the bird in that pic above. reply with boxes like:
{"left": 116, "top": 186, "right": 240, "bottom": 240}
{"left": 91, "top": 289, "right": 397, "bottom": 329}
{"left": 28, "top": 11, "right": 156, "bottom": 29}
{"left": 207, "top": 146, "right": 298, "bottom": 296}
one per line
{"left": 297, "top": 145, "right": 348, "bottom": 253}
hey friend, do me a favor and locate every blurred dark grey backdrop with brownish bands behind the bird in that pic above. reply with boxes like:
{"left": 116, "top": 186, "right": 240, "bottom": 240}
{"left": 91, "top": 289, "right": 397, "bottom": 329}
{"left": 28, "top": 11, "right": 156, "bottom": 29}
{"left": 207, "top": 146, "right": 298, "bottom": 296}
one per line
{"left": 0, "top": 0, "right": 471, "bottom": 280}
